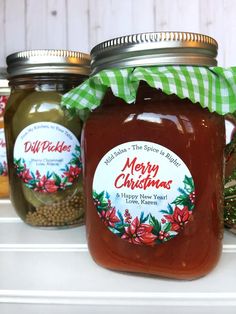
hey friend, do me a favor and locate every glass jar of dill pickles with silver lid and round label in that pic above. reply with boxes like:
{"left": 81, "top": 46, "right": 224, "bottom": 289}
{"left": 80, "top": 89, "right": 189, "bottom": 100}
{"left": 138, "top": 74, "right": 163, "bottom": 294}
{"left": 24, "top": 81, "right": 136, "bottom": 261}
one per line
{"left": 4, "top": 50, "right": 90, "bottom": 227}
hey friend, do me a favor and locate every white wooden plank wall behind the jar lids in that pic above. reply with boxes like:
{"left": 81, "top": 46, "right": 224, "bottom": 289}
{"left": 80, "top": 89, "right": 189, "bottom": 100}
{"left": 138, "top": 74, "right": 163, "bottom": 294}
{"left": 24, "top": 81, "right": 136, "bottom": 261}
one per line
{"left": 0, "top": 0, "right": 236, "bottom": 67}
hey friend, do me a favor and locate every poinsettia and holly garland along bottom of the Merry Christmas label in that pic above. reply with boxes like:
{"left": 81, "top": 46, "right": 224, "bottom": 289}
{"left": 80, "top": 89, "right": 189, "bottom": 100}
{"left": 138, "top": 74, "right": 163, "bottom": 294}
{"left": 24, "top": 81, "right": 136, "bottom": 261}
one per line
{"left": 93, "top": 176, "right": 195, "bottom": 245}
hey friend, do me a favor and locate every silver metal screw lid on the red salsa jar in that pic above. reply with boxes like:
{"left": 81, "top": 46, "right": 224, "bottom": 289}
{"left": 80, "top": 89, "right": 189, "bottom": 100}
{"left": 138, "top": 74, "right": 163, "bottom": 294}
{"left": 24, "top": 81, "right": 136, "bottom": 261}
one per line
{"left": 91, "top": 32, "right": 218, "bottom": 74}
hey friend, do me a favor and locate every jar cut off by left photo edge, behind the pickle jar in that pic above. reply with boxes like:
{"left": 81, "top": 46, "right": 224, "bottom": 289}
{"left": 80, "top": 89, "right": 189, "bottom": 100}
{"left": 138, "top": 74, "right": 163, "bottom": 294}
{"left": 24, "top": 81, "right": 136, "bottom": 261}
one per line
{"left": 0, "top": 70, "right": 10, "bottom": 198}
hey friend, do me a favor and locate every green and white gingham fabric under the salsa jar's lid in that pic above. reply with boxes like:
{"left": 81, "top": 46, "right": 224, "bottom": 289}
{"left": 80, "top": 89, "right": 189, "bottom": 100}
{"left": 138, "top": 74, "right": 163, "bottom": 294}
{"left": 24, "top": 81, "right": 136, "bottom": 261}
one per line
{"left": 62, "top": 65, "right": 236, "bottom": 115}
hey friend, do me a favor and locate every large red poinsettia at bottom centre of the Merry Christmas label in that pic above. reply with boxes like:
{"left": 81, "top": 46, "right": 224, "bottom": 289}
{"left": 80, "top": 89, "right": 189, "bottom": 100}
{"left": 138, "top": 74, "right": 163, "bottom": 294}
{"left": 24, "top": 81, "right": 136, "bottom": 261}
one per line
{"left": 121, "top": 217, "right": 157, "bottom": 245}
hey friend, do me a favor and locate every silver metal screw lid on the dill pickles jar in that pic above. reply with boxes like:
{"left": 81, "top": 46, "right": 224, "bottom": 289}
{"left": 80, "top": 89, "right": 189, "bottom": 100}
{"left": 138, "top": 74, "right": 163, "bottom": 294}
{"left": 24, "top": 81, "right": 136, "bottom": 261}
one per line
{"left": 7, "top": 49, "right": 90, "bottom": 78}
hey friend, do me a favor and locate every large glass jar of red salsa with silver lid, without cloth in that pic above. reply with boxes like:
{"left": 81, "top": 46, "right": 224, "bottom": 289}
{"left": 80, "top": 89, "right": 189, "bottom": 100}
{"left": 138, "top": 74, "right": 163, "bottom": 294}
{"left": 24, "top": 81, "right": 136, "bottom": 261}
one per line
{"left": 81, "top": 32, "right": 225, "bottom": 279}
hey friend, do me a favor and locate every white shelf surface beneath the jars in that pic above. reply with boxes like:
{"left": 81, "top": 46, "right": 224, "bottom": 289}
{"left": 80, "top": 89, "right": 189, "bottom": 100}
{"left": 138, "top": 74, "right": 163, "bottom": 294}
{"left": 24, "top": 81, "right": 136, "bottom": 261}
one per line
{"left": 0, "top": 200, "right": 236, "bottom": 314}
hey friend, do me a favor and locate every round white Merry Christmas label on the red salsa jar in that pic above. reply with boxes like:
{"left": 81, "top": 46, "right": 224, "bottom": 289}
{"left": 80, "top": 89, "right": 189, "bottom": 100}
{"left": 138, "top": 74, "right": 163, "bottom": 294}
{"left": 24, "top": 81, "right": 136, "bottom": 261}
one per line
{"left": 93, "top": 141, "right": 195, "bottom": 245}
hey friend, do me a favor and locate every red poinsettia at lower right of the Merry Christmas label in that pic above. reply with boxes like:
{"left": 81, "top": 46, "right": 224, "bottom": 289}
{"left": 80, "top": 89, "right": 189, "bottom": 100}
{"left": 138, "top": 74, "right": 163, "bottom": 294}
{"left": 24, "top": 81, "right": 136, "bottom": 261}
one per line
{"left": 164, "top": 206, "right": 191, "bottom": 231}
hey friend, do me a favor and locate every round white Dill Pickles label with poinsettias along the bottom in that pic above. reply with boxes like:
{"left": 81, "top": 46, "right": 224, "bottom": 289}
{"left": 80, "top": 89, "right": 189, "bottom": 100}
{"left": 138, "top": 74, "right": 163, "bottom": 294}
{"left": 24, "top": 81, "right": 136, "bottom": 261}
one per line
{"left": 14, "top": 122, "right": 82, "bottom": 193}
